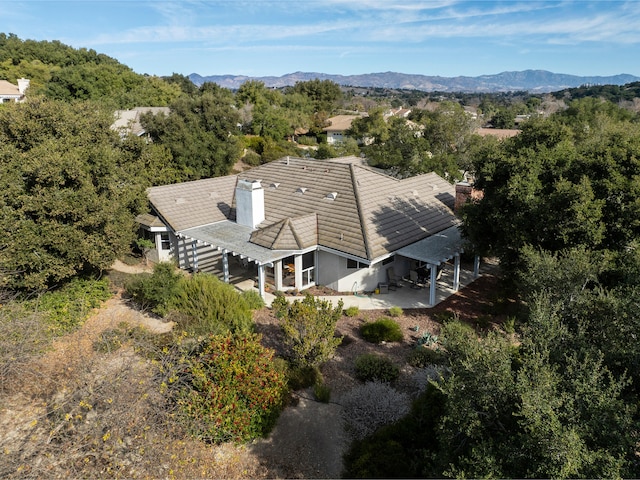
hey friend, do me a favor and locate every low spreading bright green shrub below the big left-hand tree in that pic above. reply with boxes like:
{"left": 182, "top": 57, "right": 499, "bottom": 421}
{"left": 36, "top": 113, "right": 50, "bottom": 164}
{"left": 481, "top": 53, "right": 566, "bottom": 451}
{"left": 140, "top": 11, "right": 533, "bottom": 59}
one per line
{"left": 33, "top": 278, "right": 113, "bottom": 335}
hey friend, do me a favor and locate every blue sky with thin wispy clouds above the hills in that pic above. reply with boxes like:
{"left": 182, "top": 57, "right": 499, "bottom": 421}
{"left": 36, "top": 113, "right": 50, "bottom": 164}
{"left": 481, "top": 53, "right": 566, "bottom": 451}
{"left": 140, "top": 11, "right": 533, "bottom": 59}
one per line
{"left": 5, "top": 0, "right": 640, "bottom": 77}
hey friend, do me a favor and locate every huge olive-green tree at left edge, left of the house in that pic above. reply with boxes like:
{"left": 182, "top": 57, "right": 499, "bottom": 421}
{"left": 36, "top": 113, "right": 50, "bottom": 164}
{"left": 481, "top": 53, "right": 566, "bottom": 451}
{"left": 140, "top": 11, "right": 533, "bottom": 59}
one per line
{"left": 0, "top": 99, "right": 148, "bottom": 289}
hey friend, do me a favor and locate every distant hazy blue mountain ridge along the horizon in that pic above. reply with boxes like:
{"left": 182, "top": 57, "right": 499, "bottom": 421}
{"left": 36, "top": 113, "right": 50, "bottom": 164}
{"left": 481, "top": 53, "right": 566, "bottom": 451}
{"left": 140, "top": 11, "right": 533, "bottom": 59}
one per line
{"left": 189, "top": 70, "right": 640, "bottom": 93}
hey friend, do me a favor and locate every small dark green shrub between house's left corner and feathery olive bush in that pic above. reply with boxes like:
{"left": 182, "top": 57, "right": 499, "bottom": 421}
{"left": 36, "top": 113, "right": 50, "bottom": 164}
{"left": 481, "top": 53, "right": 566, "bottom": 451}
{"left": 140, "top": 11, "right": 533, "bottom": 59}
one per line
{"left": 125, "top": 262, "right": 183, "bottom": 316}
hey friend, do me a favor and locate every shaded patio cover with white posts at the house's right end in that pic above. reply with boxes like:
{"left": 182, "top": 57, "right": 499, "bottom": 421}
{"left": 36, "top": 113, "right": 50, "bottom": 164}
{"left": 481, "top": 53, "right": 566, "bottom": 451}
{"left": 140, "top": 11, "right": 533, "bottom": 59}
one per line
{"left": 396, "top": 225, "right": 480, "bottom": 305}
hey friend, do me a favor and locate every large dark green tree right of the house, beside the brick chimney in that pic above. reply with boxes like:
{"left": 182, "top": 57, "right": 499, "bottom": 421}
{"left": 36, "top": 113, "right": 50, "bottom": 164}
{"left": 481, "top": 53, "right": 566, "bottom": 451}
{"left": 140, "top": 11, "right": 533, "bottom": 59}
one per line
{"left": 464, "top": 99, "right": 640, "bottom": 266}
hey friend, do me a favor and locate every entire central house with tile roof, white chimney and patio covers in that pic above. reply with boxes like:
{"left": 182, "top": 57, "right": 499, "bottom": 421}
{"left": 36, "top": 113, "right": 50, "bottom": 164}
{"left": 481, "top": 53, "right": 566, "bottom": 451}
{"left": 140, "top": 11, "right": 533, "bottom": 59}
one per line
{"left": 138, "top": 157, "right": 478, "bottom": 305}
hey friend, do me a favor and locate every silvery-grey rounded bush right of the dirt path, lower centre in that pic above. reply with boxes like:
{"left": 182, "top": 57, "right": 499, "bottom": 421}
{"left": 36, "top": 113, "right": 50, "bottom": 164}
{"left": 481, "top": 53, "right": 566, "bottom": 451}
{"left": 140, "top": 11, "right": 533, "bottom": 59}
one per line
{"left": 341, "top": 382, "right": 411, "bottom": 439}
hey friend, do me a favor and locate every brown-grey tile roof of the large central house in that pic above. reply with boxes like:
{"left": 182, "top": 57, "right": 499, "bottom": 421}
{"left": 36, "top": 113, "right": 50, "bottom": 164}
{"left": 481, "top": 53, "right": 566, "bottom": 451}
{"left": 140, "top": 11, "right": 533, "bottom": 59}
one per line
{"left": 148, "top": 158, "right": 458, "bottom": 260}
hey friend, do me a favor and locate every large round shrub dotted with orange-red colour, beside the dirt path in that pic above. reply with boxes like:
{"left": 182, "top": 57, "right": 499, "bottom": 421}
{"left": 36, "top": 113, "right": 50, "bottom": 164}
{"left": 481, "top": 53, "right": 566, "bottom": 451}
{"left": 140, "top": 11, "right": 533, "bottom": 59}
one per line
{"left": 174, "top": 334, "right": 287, "bottom": 444}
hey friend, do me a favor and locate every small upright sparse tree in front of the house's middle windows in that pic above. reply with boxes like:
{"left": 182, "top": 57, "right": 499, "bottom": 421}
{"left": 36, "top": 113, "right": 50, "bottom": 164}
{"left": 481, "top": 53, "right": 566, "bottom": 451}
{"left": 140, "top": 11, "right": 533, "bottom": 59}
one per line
{"left": 273, "top": 295, "right": 343, "bottom": 367}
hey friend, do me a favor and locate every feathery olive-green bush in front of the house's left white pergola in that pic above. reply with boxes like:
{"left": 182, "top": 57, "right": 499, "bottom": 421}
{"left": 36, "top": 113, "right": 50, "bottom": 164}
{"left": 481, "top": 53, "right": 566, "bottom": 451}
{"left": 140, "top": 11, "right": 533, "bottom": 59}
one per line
{"left": 167, "top": 273, "right": 253, "bottom": 335}
